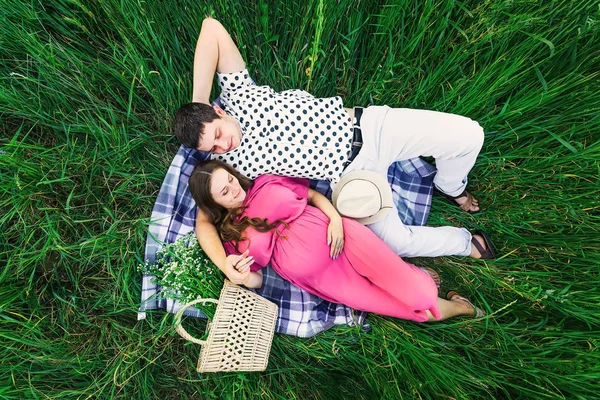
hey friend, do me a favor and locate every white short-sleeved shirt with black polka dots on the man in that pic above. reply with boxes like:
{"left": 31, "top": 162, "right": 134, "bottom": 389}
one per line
{"left": 214, "top": 70, "right": 352, "bottom": 182}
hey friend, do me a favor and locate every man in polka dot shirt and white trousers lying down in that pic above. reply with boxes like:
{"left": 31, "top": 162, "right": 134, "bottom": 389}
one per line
{"left": 174, "top": 18, "right": 493, "bottom": 284}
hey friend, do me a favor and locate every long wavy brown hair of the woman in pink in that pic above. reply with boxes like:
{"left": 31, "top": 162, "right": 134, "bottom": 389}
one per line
{"left": 189, "top": 160, "right": 288, "bottom": 251}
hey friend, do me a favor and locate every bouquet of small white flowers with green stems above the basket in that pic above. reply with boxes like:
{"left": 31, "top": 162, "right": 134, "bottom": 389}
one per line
{"left": 139, "top": 232, "right": 225, "bottom": 317}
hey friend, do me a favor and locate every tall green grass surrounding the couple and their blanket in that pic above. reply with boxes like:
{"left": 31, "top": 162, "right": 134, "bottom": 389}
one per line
{"left": 0, "top": 0, "right": 600, "bottom": 399}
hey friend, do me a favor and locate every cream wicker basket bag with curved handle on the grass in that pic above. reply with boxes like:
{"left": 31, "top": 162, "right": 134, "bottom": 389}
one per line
{"left": 175, "top": 280, "right": 277, "bottom": 372}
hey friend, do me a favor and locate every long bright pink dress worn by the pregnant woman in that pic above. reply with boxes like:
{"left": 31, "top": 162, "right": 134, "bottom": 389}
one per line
{"left": 225, "top": 175, "right": 440, "bottom": 322}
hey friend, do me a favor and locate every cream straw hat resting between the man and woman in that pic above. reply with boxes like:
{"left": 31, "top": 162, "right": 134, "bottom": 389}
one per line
{"left": 331, "top": 170, "right": 393, "bottom": 225}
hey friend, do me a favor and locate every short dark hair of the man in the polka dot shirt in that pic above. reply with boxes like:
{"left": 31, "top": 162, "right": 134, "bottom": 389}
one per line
{"left": 173, "top": 103, "right": 221, "bottom": 149}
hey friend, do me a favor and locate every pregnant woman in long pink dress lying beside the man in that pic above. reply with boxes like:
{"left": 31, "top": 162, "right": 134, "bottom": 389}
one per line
{"left": 189, "top": 160, "right": 484, "bottom": 322}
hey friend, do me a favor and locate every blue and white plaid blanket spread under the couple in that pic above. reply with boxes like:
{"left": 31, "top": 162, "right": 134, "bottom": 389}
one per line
{"left": 138, "top": 146, "right": 435, "bottom": 337}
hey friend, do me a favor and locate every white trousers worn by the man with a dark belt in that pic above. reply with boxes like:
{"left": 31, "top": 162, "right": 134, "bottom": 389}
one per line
{"left": 343, "top": 106, "right": 484, "bottom": 257}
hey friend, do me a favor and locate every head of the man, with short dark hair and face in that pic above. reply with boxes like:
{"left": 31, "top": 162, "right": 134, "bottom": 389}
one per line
{"left": 173, "top": 103, "right": 242, "bottom": 154}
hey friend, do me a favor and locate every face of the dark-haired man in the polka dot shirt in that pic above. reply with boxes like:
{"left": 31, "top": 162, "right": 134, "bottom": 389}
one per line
{"left": 196, "top": 106, "right": 242, "bottom": 154}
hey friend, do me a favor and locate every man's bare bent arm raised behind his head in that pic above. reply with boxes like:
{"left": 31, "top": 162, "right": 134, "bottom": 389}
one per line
{"left": 192, "top": 18, "right": 246, "bottom": 103}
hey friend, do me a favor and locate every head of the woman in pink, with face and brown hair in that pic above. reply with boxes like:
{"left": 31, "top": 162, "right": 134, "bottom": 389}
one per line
{"left": 189, "top": 160, "right": 252, "bottom": 224}
